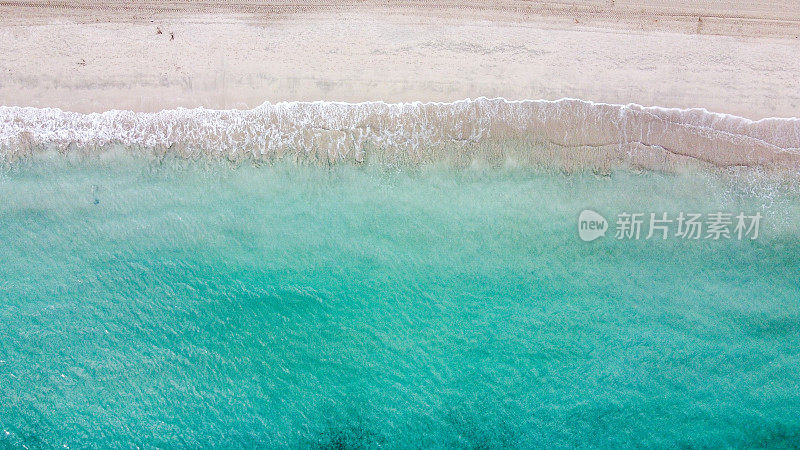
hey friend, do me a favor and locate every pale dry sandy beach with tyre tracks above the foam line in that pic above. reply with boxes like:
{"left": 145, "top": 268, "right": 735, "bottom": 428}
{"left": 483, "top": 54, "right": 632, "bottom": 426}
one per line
{"left": 0, "top": 0, "right": 800, "bottom": 119}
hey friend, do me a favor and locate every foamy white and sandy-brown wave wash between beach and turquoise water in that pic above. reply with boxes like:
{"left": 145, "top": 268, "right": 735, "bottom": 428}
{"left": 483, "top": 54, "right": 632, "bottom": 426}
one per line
{"left": 0, "top": 98, "right": 800, "bottom": 172}
